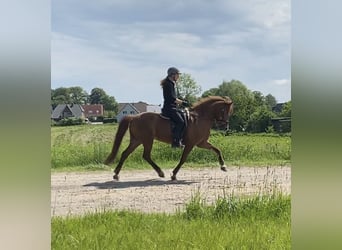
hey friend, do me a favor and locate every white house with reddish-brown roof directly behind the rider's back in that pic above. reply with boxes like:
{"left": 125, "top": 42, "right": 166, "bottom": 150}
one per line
{"left": 116, "top": 102, "right": 161, "bottom": 122}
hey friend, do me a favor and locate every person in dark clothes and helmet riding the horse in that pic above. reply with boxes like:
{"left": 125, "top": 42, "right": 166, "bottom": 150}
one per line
{"left": 160, "top": 67, "right": 187, "bottom": 148}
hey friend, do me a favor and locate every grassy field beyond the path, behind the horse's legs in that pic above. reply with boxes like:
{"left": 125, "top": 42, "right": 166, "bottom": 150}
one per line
{"left": 51, "top": 124, "right": 291, "bottom": 171}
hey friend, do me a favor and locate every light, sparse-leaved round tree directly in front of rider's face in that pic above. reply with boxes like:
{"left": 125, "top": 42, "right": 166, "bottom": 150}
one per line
{"left": 177, "top": 73, "right": 201, "bottom": 104}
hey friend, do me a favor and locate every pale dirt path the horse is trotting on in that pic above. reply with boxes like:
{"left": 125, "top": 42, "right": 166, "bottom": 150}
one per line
{"left": 51, "top": 167, "right": 291, "bottom": 216}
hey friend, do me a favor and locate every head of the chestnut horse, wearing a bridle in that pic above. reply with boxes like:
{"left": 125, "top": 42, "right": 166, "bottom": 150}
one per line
{"left": 213, "top": 97, "right": 233, "bottom": 130}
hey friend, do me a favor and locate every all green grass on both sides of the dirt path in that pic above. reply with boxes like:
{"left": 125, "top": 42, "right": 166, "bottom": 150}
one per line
{"left": 51, "top": 124, "right": 291, "bottom": 250}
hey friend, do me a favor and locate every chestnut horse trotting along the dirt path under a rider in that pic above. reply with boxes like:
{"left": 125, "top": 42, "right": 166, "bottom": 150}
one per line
{"left": 105, "top": 96, "right": 233, "bottom": 180}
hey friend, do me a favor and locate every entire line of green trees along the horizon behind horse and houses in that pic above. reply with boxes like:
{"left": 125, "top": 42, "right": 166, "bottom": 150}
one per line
{"left": 51, "top": 73, "right": 291, "bottom": 133}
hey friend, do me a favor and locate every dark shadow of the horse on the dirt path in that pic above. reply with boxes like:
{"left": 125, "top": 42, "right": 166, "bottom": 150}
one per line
{"left": 83, "top": 179, "right": 197, "bottom": 189}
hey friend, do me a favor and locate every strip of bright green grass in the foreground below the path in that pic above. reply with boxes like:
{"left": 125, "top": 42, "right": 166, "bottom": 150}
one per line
{"left": 51, "top": 194, "right": 291, "bottom": 250}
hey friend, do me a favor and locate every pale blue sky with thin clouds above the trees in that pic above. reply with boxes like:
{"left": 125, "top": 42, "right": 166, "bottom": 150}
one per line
{"left": 51, "top": 0, "right": 291, "bottom": 104}
